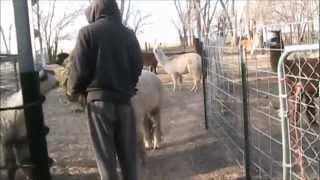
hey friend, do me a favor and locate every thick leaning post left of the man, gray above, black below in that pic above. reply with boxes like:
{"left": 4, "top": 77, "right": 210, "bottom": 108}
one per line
{"left": 13, "top": 0, "right": 51, "bottom": 180}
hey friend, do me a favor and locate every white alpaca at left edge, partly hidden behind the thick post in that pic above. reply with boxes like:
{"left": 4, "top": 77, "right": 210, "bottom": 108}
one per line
{"left": 0, "top": 71, "right": 58, "bottom": 180}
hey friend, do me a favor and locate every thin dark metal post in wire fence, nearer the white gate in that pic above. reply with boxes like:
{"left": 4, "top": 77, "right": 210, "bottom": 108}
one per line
{"left": 240, "top": 46, "right": 251, "bottom": 180}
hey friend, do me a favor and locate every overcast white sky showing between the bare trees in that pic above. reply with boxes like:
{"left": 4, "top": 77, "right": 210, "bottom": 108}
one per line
{"left": 0, "top": 0, "right": 188, "bottom": 52}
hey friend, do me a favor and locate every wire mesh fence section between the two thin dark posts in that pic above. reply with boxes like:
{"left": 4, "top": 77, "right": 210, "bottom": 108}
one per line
{"left": 204, "top": 34, "right": 244, "bottom": 173}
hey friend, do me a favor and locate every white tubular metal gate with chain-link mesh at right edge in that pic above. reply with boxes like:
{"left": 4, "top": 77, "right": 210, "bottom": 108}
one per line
{"left": 278, "top": 44, "right": 320, "bottom": 179}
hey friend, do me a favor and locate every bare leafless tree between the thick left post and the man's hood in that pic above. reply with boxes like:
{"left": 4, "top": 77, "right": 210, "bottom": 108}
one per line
{"left": 33, "top": 0, "right": 83, "bottom": 63}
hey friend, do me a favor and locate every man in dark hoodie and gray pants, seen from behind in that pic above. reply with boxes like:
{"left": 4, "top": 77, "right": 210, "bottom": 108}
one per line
{"left": 69, "top": 0, "right": 143, "bottom": 180}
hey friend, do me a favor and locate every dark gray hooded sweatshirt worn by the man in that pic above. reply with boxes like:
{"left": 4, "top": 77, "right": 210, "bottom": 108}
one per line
{"left": 69, "top": 0, "right": 143, "bottom": 102}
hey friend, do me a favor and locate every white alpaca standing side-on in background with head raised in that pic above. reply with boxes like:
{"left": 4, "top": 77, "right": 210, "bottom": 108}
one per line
{"left": 153, "top": 46, "right": 202, "bottom": 92}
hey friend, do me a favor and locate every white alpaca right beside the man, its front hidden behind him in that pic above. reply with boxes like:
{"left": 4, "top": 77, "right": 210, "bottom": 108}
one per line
{"left": 131, "top": 70, "right": 162, "bottom": 163}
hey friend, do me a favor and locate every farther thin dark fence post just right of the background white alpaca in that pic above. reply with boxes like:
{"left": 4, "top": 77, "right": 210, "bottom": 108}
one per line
{"left": 193, "top": 38, "right": 209, "bottom": 130}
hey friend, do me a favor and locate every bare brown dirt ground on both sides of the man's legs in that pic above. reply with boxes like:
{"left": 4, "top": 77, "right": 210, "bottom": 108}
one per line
{"left": 44, "top": 70, "right": 243, "bottom": 180}
